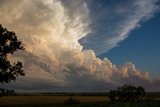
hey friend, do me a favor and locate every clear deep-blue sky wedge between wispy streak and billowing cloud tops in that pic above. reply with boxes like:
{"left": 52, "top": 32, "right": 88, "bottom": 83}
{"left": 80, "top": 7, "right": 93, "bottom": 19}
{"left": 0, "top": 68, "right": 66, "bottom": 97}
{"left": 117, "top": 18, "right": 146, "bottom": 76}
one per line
{"left": 99, "top": 13, "right": 160, "bottom": 77}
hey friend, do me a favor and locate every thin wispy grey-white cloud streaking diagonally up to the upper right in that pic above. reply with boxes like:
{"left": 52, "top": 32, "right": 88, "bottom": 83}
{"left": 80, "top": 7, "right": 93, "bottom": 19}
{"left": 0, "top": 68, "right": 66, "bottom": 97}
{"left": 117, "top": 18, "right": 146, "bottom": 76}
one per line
{"left": 80, "top": 0, "right": 159, "bottom": 54}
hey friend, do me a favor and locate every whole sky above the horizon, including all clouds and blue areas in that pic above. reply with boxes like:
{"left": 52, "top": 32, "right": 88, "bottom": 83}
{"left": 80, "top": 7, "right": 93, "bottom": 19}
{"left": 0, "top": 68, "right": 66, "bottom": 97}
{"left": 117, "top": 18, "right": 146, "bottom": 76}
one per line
{"left": 0, "top": 0, "right": 160, "bottom": 92}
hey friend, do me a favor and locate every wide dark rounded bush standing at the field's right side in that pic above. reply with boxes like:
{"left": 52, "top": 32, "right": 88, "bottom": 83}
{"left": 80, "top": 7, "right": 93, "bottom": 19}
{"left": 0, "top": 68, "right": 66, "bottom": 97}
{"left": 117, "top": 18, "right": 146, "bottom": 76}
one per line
{"left": 109, "top": 84, "right": 145, "bottom": 101}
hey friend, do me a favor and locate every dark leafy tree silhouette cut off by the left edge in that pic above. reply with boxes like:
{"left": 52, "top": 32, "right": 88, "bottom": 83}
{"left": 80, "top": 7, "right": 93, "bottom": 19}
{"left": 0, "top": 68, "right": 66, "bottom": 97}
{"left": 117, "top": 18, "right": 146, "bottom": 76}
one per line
{"left": 0, "top": 25, "right": 25, "bottom": 84}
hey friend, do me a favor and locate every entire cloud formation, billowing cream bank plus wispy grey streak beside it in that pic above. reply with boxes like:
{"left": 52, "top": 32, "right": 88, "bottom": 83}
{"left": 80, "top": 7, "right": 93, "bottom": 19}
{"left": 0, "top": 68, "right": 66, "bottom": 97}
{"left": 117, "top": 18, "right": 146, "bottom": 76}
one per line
{"left": 0, "top": 0, "right": 160, "bottom": 91}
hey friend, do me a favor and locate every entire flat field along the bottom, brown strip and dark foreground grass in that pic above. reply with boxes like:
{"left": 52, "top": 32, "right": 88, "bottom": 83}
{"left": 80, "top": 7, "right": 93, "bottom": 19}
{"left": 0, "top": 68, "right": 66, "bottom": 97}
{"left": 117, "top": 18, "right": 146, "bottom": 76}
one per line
{"left": 0, "top": 93, "right": 160, "bottom": 107}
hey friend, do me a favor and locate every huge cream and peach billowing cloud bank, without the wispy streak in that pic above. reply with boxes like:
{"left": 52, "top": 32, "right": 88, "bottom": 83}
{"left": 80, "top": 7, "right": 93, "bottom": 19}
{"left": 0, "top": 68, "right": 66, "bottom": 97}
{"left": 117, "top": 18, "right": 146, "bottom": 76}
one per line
{"left": 0, "top": 0, "right": 160, "bottom": 91}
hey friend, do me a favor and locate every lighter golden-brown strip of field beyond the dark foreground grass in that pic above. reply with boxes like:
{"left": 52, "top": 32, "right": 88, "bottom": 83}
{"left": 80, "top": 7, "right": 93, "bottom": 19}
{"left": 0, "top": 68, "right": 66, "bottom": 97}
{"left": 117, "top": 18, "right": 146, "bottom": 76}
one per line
{"left": 0, "top": 96, "right": 109, "bottom": 105}
